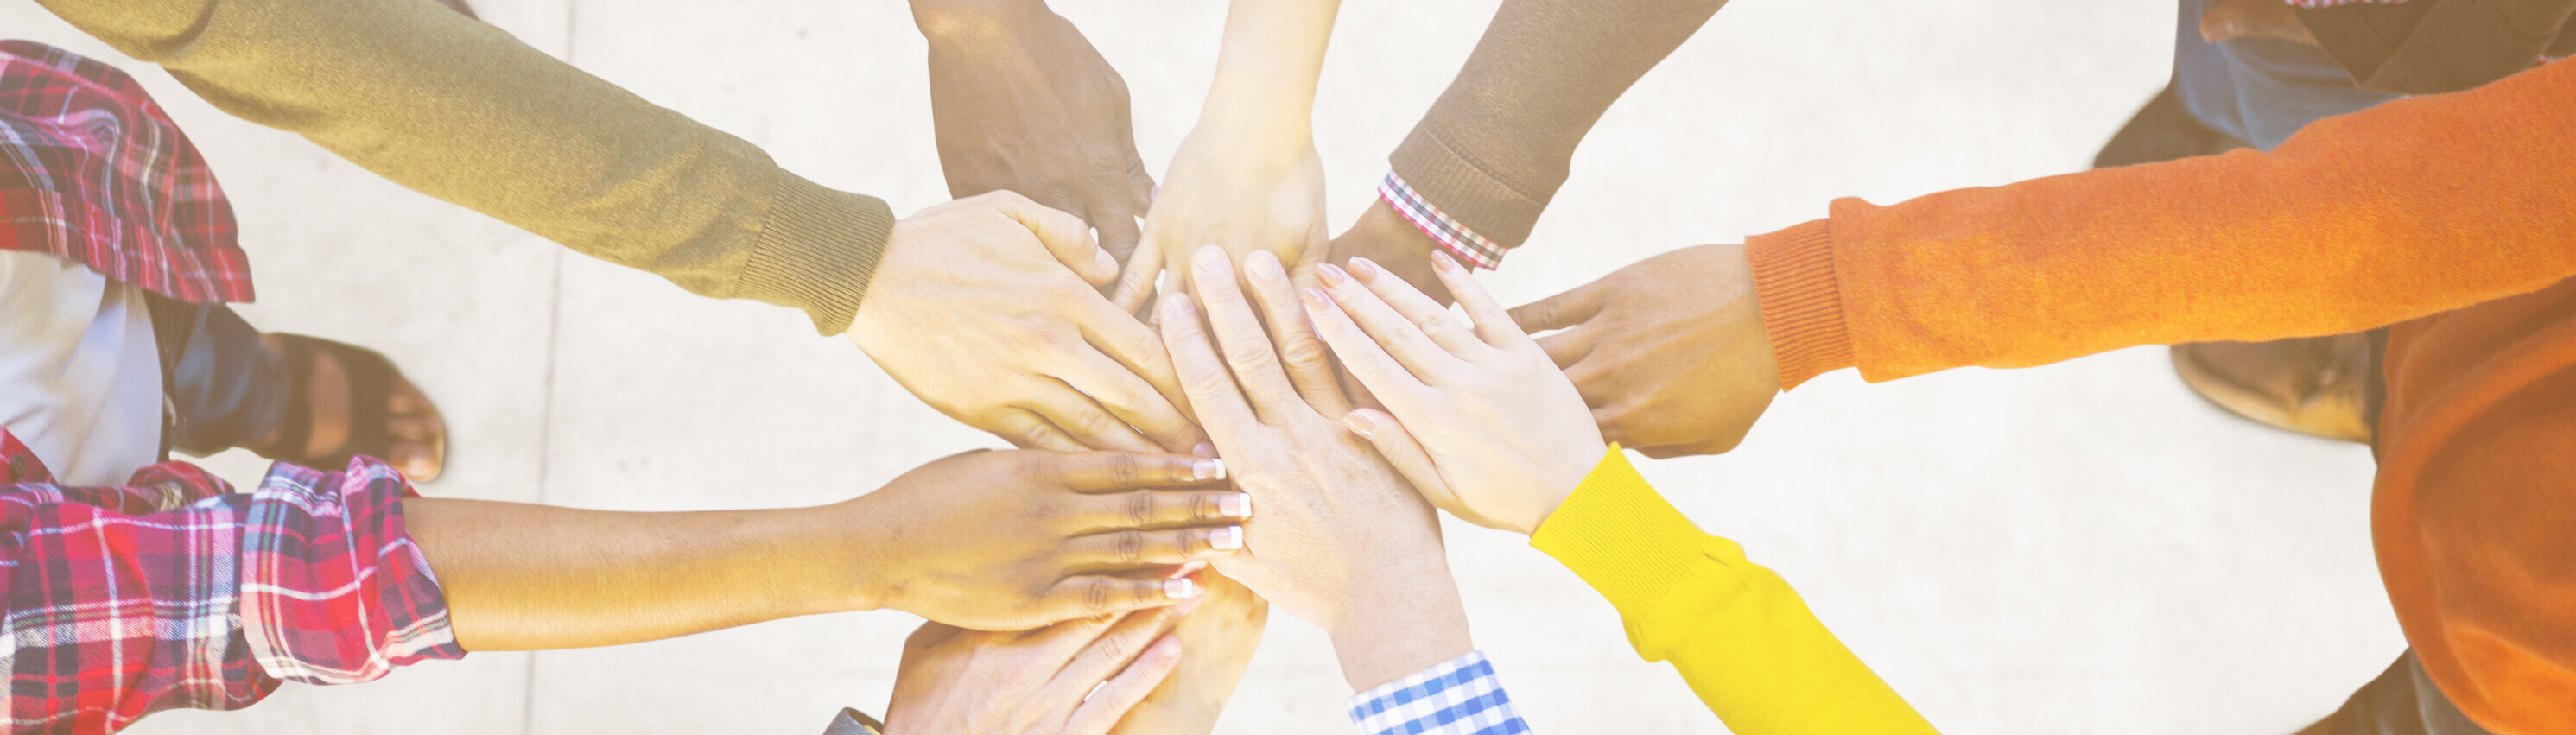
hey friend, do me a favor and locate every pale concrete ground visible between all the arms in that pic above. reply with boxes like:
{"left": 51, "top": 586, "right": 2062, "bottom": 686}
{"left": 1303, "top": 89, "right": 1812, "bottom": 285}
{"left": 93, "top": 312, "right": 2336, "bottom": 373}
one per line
{"left": 0, "top": 0, "right": 2403, "bottom": 735}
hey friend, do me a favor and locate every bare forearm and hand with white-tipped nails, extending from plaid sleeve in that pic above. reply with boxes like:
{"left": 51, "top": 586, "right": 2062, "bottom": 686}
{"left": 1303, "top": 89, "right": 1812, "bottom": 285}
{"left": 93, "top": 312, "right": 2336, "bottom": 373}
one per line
{"left": 402, "top": 452, "right": 1252, "bottom": 649}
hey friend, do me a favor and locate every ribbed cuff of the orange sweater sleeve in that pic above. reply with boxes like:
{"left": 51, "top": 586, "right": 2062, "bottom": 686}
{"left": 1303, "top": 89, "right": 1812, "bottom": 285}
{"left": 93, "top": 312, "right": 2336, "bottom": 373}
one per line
{"left": 1744, "top": 219, "right": 1857, "bottom": 390}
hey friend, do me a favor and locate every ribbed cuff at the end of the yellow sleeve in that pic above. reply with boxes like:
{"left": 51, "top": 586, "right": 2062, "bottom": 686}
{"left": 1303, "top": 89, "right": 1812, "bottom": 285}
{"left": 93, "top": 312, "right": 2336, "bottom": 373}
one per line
{"left": 1530, "top": 444, "right": 1708, "bottom": 619}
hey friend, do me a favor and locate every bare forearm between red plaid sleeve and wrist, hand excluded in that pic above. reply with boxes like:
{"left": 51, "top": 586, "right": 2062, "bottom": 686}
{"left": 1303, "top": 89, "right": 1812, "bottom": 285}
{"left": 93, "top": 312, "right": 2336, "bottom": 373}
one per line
{"left": 404, "top": 497, "right": 873, "bottom": 649}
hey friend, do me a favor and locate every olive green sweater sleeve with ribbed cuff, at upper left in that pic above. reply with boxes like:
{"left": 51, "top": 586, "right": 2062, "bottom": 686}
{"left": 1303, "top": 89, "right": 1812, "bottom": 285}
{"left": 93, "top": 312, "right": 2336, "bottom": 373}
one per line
{"left": 39, "top": 0, "right": 894, "bottom": 335}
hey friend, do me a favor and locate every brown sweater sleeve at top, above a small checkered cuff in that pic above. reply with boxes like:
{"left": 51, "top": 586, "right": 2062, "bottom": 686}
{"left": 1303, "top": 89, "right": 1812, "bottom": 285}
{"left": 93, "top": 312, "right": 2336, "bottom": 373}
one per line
{"left": 1388, "top": 0, "right": 1726, "bottom": 248}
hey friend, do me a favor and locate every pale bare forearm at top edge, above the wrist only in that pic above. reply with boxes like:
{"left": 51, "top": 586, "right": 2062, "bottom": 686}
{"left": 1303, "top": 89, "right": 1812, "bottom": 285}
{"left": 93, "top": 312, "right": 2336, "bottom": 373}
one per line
{"left": 1198, "top": 0, "right": 1342, "bottom": 136}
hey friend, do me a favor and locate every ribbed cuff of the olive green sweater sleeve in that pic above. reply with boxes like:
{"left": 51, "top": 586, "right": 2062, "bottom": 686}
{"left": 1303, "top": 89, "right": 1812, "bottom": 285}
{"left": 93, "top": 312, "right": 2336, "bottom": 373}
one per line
{"left": 734, "top": 170, "right": 894, "bottom": 335}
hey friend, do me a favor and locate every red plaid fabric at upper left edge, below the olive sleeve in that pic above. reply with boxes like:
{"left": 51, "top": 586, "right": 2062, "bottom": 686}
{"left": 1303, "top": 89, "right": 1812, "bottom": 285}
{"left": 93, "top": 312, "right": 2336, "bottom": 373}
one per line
{"left": 0, "top": 41, "right": 252, "bottom": 304}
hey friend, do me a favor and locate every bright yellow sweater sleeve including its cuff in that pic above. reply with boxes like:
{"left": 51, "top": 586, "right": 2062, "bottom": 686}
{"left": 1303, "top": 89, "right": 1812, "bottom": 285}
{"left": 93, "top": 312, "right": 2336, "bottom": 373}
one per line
{"left": 1530, "top": 447, "right": 1934, "bottom": 735}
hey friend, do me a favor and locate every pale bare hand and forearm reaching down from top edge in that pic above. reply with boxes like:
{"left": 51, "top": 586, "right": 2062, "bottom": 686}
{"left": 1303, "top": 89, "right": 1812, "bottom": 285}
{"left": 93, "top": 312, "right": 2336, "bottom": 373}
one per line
{"left": 1113, "top": 0, "right": 1342, "bottom": 312}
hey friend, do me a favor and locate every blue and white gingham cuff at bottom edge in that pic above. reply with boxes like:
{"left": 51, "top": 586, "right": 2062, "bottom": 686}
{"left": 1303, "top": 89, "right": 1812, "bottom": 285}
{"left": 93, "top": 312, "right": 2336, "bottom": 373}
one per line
{"left": 1350, "top": 649, "right": 1530, "bottom": 735}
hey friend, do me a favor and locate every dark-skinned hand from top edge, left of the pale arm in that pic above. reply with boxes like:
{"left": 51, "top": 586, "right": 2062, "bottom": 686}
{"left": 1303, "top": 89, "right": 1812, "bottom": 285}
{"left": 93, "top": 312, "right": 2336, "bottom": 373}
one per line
{"left": 912, "top": 0, "right": 1154, "bottom": 261}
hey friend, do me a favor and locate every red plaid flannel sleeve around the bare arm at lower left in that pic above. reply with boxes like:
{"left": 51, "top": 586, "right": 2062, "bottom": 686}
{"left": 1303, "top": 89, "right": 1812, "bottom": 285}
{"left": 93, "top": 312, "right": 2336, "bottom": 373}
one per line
{"left": 0, "top": 431, "right": 464, "bottom": 732}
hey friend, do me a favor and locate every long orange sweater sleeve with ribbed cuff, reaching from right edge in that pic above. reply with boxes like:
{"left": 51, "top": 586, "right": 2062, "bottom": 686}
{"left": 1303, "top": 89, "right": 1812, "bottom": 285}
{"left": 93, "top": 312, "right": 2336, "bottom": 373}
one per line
{"left": 1747, "top": 62, "right": 2576, "bottom": 387}
